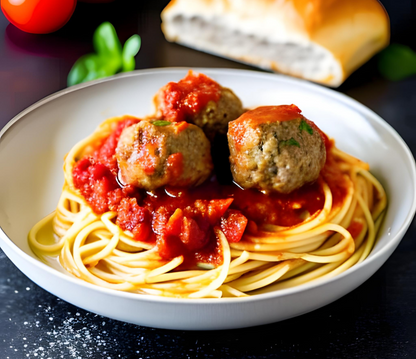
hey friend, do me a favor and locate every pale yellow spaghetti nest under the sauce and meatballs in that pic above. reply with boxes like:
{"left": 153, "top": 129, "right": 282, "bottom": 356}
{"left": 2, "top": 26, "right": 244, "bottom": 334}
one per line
{"left": 29, "top": 114, "right": 387, "bottom": 298}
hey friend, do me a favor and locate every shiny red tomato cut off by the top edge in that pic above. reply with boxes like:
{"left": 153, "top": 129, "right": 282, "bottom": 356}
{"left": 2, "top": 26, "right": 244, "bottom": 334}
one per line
{"left": 1, "top": 0, "right": 77, "bottom": 34}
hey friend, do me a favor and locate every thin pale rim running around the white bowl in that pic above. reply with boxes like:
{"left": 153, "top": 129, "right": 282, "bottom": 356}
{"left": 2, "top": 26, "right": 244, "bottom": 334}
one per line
{"left": 0, "top": 67, "right": 416, "bottom": 306}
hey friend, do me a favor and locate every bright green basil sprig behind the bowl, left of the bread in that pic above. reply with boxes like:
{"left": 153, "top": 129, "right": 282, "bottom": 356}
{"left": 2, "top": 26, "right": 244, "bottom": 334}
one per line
{"left": 67, "top": 22, "right": 141, "bottom": 86}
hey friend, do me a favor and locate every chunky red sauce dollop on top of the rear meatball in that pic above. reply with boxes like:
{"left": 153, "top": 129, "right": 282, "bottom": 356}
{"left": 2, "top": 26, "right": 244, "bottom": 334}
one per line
{"left": 156, "top": 71, "right": 221, "bottom": 122}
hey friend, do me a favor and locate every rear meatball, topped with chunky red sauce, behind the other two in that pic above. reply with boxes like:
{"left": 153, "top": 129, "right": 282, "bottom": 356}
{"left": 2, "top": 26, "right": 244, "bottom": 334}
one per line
{"left": 154, "top": 71, "right": 243, "bottom": 140}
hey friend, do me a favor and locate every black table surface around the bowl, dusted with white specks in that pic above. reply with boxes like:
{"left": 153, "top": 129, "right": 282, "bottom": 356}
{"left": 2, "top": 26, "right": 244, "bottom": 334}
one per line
{"left": 0, "top": 0, "right": 416, "bottom": 358}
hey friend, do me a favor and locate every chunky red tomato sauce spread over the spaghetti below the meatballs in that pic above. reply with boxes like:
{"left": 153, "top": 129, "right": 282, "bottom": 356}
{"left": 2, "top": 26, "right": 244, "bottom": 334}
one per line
{"left": 73, "top": 117, "right": 346, "bottom": 268}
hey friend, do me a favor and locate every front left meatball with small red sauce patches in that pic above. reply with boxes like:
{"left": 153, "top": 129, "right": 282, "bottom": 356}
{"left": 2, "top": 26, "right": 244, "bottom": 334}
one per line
{"left": 116, "top": 121, "right": 213, "bottom": 190}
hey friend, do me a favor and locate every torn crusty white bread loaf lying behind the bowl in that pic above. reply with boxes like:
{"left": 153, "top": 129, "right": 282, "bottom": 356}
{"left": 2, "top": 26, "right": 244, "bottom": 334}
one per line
{"left": 161, "top": 0, "right": 390, "bottom": 87}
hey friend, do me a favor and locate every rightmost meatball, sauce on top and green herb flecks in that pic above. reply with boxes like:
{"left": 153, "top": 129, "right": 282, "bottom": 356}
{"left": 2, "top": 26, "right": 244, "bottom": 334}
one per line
{"left": 227, "top": 105, "right": 326, "bottom": 193}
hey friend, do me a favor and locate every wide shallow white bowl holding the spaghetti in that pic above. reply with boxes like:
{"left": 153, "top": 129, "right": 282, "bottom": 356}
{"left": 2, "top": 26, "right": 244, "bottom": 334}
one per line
{"left": 0, "top": 69, "right": 416, "bottom": 330}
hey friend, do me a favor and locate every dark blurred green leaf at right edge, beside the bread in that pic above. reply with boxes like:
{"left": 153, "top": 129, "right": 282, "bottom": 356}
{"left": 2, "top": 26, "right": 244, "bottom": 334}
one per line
{"left": 378, "top": 44, "right": 416, "bottom": 81}
